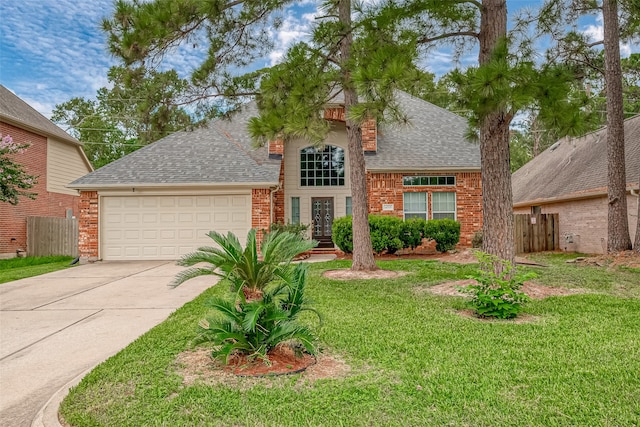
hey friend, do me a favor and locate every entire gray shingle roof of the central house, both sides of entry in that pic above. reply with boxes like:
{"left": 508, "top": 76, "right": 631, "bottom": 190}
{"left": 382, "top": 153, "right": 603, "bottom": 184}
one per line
{"left": 69, "top": 92, "right": 480, "bottom": 188}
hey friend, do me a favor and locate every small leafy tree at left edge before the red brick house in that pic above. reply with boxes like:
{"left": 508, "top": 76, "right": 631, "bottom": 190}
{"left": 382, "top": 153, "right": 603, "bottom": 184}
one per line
{"left": 0, "top": 134, "right": 37, "bottom": 205}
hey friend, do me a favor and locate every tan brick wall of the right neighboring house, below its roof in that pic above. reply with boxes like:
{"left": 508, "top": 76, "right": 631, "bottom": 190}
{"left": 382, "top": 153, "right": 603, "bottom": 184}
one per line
{"left": 514, "top": 195, "right": 638, "bottom": 254}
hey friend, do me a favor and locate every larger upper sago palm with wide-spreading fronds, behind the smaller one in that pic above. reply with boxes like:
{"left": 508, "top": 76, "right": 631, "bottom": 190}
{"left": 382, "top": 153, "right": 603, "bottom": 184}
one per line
{"left": 171, "top": 229, "right": 318, "bottom": 298}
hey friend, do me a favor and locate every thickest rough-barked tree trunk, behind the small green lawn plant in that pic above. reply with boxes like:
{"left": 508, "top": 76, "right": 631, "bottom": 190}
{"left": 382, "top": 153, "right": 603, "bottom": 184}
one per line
{"left": 478, "top": 0, "right": 515, "bottom": 272}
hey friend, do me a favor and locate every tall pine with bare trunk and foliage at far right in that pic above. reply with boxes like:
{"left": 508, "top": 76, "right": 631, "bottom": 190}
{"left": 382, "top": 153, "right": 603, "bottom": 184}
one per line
{"left": 538, "top": 0, "right": 640, "bottom": 252}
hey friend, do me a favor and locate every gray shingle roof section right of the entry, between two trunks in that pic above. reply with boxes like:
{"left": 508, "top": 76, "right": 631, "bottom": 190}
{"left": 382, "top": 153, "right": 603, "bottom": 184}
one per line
{"left": 366, "top": 91, "right": 480, "bottom": 170}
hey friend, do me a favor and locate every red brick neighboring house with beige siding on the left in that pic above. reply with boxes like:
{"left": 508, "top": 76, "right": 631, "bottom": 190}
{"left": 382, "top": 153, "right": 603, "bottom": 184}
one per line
{"left": 0, "top": 85, "right": 93, "bottom": 258}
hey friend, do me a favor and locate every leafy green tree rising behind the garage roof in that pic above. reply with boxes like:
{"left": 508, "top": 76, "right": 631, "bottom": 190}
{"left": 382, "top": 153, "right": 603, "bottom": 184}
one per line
{"left": 52, "top": 66, "right": 194, "bottom": 168}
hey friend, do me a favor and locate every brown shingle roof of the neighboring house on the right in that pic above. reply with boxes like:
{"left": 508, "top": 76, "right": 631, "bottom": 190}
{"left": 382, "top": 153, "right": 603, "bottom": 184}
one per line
{"left": 511, "top": 115, "right": 640, "bottom": 206}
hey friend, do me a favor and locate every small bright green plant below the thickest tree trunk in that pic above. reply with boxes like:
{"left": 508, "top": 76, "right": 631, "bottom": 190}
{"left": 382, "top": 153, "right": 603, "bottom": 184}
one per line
{"left": 460, "top": 252, "right": 535, "bottom": 319}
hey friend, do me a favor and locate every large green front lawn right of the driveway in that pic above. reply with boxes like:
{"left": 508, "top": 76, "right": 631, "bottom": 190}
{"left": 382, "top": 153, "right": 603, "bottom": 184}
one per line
{"left": 61, "top": 256, "right": 640, "bottom": 427}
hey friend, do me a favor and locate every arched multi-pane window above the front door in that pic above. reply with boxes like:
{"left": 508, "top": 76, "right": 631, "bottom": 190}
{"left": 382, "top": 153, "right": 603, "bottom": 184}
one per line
{"left": 300, "top": 145, "right": 344, "bottom": 187}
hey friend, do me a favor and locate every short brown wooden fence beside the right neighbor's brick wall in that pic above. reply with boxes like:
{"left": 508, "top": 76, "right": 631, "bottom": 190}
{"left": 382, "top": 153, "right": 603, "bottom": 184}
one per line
{"left": 514, "top": 214, "right": 560, "bottom": 254}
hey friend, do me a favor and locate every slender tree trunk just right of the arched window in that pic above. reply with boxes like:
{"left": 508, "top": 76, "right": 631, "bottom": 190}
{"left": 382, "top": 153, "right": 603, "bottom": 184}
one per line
{"left": 338, "top": 0, "right": 378, "bottom": 270}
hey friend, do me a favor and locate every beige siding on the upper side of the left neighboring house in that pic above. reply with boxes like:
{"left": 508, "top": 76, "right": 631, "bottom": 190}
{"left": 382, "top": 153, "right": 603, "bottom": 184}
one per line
{"left": 47, "top": 138, "right": 91, "bottom": 196}
